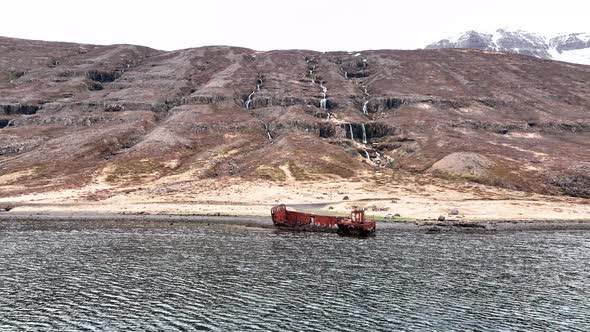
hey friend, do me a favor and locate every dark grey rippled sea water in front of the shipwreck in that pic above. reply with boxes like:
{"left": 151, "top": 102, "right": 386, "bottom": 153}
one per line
{"left": 0, "top": 222, "right": 590, "bottom": 331}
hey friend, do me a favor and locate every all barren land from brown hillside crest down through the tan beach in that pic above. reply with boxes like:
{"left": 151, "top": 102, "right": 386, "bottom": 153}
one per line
{"left": 0, "top": 38, "right": 590, "bottom": 220}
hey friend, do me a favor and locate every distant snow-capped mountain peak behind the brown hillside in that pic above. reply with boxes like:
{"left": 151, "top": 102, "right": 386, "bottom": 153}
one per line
{"left": 426, "top": 29, "right": 590, "bottom": 65}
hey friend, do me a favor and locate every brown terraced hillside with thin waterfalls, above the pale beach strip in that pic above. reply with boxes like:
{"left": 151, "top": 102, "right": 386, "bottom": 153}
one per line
{"left": 0, "top": 38, "right": 590, "bottom": 195}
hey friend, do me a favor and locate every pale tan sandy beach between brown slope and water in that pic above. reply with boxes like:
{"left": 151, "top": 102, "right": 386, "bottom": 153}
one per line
{"left": 0, "top": 173, "right": 590, "bottom": 228}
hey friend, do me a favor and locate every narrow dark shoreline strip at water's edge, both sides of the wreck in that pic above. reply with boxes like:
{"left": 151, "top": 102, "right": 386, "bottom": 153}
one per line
{"left": 0, "top": 211, "right": 590, "bottom": 233}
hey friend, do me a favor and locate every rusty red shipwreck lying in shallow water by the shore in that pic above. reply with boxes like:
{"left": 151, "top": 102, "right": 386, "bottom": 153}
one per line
{"left": 271, "top": 204, "right": 376, "bottom": 237}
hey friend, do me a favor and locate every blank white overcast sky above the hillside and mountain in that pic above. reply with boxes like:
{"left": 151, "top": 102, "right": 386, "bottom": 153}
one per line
{"left": 0, "top": 0, "right": 590, "bottom": 51}
